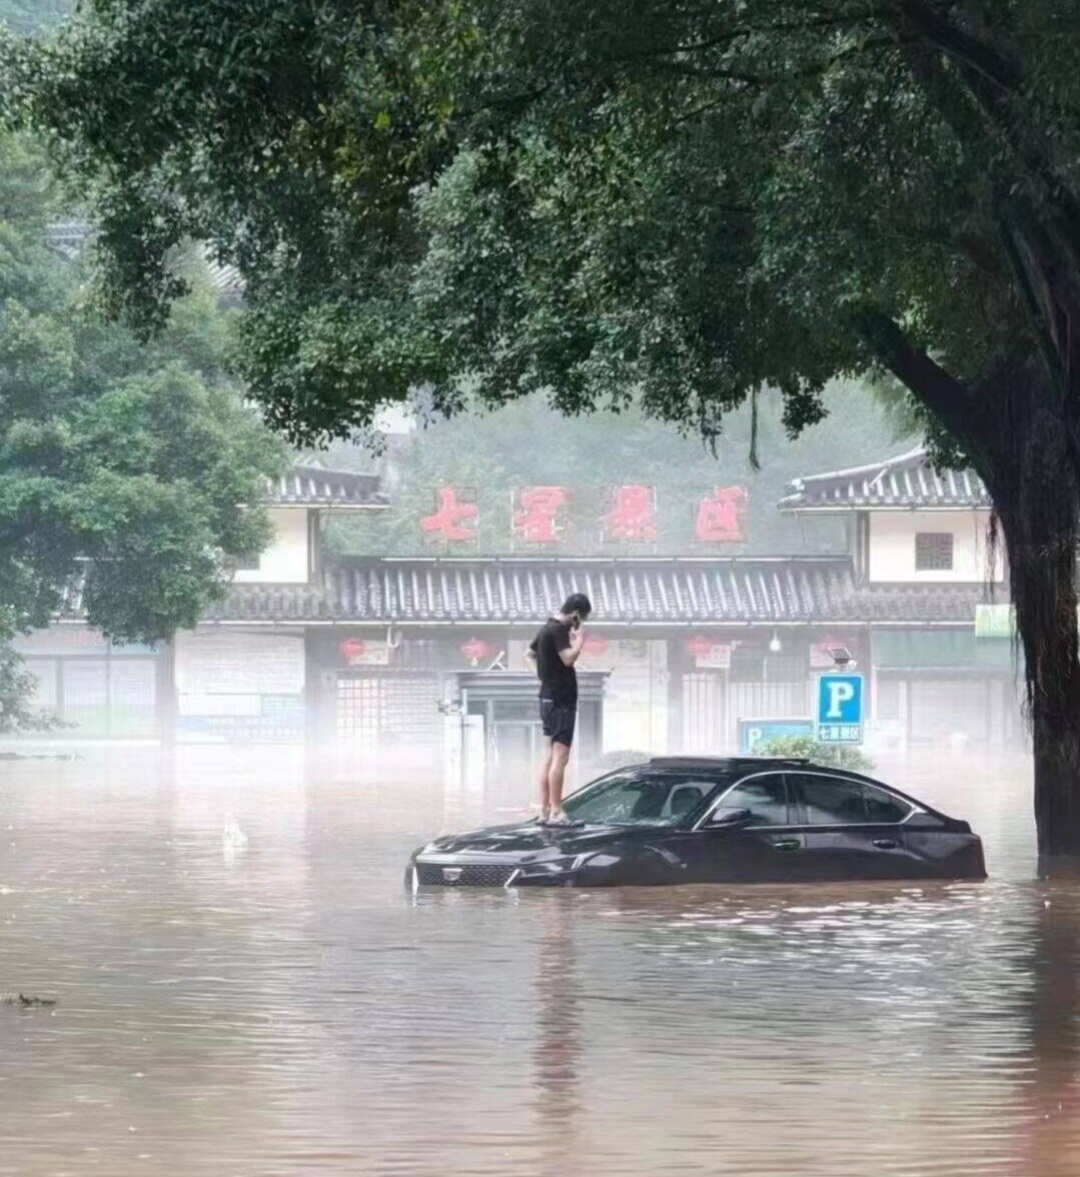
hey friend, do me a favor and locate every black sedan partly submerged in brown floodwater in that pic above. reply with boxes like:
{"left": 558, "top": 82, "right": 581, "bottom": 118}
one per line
{"left": 406, "top": 757, "right": 986, "bottom": 887}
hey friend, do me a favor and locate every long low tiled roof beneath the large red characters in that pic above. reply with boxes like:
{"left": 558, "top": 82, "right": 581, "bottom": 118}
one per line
{"left": 208, "top": 557, "right": 986, "bottom": 625}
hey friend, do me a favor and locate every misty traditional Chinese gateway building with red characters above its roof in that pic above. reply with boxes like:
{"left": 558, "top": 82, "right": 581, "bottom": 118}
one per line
{"left": 21, "top": 451, "right": 1022, "bottom": 763}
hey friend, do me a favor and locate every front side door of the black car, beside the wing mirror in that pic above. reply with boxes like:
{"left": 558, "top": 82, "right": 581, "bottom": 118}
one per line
{"left": 687, "top": 772, "right": 805, "bottom": 883}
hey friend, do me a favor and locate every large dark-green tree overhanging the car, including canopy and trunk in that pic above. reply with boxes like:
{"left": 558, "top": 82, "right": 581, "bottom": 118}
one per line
{"left": 23, "top": 0, "right": 1080, "bottom": 865}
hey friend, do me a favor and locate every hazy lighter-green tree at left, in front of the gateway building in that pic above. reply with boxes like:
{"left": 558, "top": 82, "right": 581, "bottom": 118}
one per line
{"left": 0, "top": 137, "right": 282, "bottom": 730}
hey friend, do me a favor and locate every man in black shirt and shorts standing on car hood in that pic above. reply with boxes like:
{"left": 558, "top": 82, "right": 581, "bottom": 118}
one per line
{"left": 526, "top": 592, "right": 593, "bottom": 825}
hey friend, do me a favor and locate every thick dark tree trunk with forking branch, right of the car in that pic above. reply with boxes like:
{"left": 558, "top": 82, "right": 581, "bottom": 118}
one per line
{"left": 856, "top": 313, "right": 1080, "bottom": 873}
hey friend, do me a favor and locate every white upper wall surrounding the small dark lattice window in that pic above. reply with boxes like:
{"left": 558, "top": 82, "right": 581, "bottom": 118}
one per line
{"left": 869, "top": 511, "right": 1004, "bottom": 584}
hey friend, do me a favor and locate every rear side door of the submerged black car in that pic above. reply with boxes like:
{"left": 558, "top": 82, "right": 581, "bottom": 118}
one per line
{"left": 787, "top": 772, "right": 922, "bottom": 879}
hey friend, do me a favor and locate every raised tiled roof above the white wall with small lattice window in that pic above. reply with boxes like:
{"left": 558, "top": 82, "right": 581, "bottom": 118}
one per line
{"left": 780, "top": 448, "right": 991, "bottom": 511}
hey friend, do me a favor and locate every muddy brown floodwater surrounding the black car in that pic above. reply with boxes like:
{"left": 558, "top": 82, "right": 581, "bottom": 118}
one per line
{"left": 0, "top": 749, "right": 1080, "bottom": 1177}
